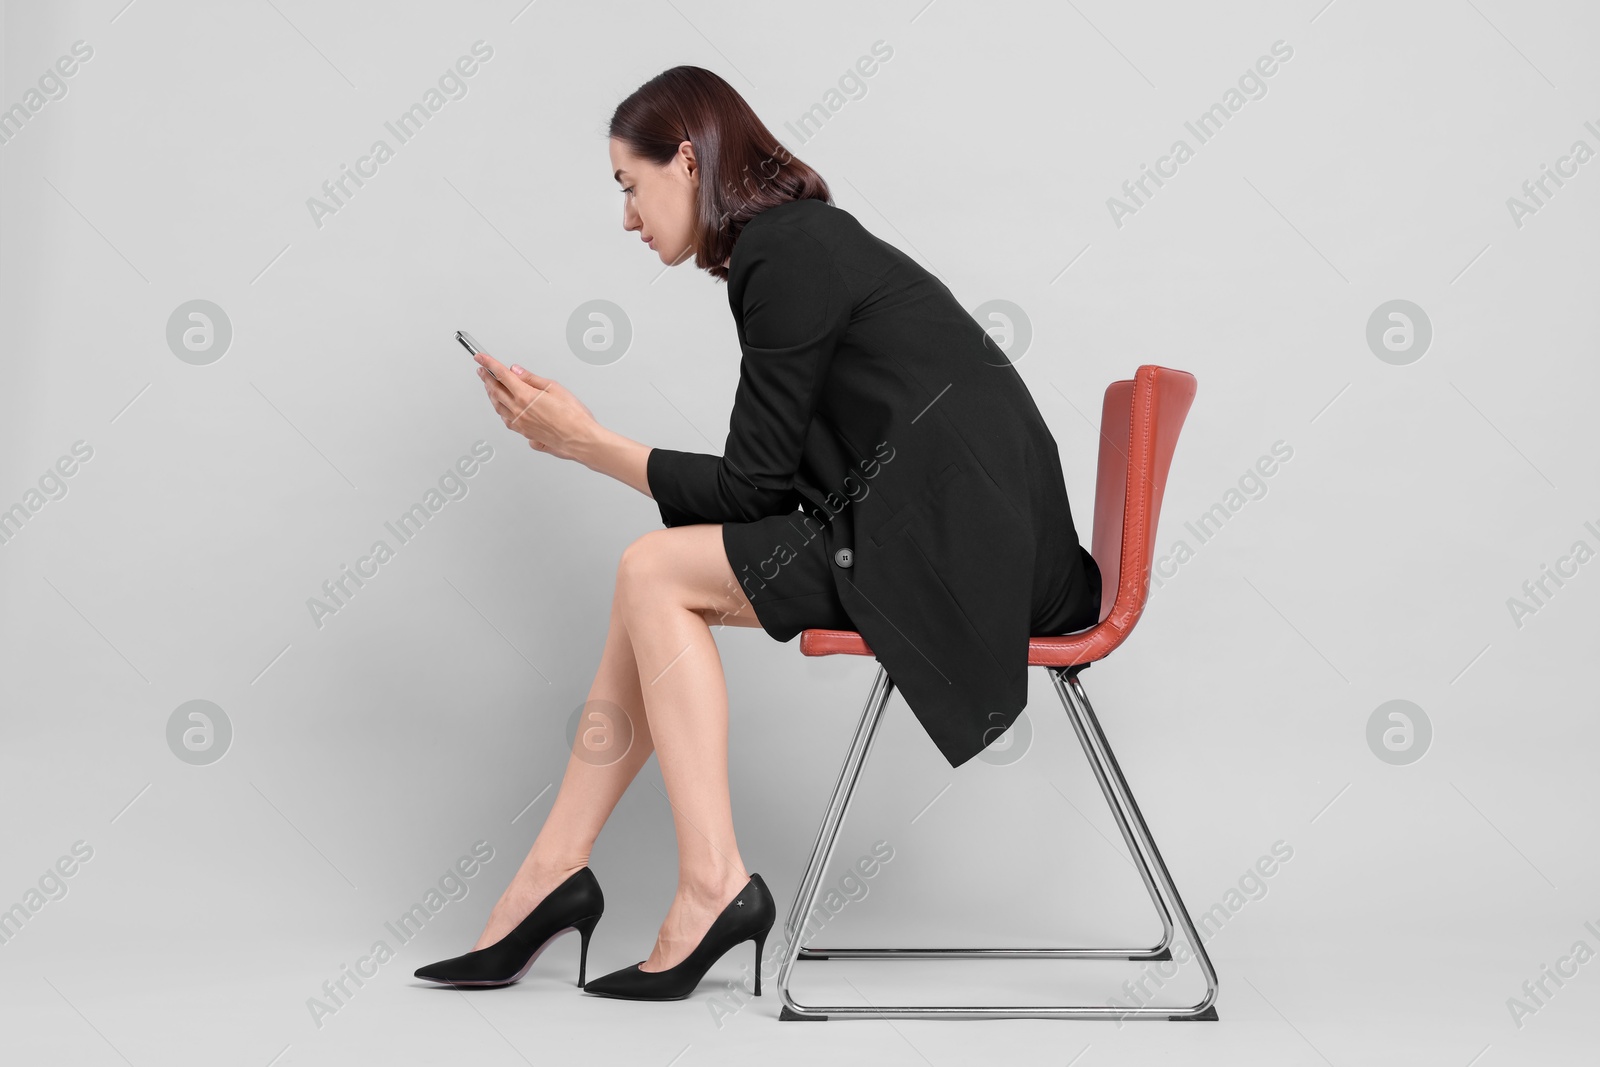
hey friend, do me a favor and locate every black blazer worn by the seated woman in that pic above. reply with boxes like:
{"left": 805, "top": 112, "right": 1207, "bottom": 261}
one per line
{"left": 646, "top": 200, "right": 1099, "bottom": 766}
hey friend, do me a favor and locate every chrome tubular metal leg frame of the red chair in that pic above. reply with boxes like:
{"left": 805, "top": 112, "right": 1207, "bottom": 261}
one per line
{"left": 778, "top": 665, "right": 1218, "bottom": 1021}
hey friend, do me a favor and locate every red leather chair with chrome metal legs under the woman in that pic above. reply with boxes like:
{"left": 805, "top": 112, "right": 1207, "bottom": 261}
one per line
{"left": 778, "top": 365, "right": 1218, "bottom": 1021}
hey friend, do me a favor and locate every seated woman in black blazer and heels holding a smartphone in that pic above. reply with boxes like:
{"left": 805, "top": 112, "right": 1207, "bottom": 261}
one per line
{"left": 416, "top": 67, "right": 1101, "bottom": 1000}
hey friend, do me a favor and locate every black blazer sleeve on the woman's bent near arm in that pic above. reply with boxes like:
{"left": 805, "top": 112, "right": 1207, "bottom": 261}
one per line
{"left": 645, "top": 216, "right": 850, "bottom": 526}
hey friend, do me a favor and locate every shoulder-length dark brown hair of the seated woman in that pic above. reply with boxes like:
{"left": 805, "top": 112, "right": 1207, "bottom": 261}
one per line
{"left": 610, "top": 67, "right": 834, "bottom": 282}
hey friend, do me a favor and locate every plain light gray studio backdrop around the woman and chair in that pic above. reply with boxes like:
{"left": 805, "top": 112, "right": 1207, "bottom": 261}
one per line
{"left": 0, "top": 0, "right": 1600, "bottom": 1067}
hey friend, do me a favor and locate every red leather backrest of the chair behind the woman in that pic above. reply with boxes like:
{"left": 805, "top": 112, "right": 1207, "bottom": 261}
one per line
{"left": 1090, "top": 363, "right": 1197, "bottom": 635}
